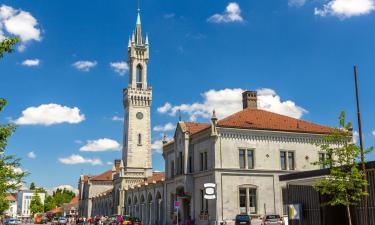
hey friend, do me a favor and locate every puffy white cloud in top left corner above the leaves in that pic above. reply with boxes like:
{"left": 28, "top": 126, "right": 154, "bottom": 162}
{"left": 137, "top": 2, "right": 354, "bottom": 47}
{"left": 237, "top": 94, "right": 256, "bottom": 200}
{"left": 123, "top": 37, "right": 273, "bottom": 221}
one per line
{"left": 0, "top": 5, "right": 41, "bottom": 51}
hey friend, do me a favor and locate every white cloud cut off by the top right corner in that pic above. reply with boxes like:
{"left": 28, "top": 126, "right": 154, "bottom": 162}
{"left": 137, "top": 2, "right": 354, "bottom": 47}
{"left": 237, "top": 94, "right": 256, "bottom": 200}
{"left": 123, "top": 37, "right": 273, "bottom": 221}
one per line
{"left": 315, "top": 0, "right": 375, "bottom": 19}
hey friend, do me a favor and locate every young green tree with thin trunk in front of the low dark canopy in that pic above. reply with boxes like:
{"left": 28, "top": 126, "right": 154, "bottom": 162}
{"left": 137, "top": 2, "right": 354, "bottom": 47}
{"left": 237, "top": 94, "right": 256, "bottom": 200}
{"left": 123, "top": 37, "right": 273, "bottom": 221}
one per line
{"left": 314, "top": 112, "right": 372, "bottom": 225}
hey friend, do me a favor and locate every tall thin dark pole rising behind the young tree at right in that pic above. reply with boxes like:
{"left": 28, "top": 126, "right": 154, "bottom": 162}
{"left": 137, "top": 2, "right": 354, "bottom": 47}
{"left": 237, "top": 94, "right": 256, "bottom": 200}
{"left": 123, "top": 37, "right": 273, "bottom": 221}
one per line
{"left": 354, "top": 65, "right": 369, "bottom": 224}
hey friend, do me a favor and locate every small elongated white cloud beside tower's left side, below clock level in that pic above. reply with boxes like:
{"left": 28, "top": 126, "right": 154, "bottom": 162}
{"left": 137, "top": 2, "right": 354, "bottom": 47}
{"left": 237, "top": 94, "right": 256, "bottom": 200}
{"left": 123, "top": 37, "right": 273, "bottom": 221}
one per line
{"left": 79, "top": 138, "right": 121, "bottom": 152}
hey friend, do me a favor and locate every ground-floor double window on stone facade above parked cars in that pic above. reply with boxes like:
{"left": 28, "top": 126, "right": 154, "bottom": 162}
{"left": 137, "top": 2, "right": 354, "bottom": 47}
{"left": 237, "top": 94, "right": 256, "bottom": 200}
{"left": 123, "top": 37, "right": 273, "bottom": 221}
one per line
{"left": 238, "top": 187, "right": 258, "bottom": 214}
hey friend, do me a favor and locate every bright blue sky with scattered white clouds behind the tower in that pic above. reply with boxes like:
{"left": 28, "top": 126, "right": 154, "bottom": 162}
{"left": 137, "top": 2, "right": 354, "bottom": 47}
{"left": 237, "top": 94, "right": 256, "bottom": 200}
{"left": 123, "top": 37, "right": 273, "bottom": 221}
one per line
{"left": 0, "top": 0, "right": 375, "bottom": 192}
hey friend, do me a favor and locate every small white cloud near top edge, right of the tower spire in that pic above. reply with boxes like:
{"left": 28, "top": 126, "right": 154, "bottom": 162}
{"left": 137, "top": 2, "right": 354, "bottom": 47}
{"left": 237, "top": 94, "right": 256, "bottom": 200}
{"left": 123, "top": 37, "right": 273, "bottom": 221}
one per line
{"left": 207, "top": 2, "right": 243, "bottom": 23}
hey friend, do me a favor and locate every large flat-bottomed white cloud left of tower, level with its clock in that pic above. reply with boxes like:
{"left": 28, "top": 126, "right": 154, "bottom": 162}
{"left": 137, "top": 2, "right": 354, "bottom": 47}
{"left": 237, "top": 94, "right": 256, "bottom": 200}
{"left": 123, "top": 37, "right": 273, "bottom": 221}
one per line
{"left": 15, "top": 103, "right": 85, "bottom": 126}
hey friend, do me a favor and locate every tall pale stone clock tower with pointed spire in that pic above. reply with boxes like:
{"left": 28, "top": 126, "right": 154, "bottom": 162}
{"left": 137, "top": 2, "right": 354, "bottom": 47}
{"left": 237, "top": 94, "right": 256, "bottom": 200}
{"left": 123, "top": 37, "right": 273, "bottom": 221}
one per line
{"left": 122, "top": 10, "right": 152, "bottom": 177}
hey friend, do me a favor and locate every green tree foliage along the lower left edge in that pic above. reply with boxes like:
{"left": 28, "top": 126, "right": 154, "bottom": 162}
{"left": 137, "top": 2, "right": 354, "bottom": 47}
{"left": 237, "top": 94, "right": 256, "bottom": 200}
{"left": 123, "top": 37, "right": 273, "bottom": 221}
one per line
{"left": 0, "top": 98, "right": 27, "bottom": 215}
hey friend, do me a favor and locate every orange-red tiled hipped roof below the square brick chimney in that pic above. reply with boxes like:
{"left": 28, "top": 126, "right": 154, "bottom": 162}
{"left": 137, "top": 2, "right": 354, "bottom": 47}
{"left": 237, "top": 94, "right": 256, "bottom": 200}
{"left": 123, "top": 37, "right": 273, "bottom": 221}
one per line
{"left": 217, "top": 108, "right": 334, "bottom": 134}
